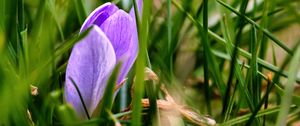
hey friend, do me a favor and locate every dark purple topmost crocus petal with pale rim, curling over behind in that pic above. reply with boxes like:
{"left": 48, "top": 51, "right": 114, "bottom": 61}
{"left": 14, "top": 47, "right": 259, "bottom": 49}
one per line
{"left": 80, "top": 2, "right": 119, "bottom": 32}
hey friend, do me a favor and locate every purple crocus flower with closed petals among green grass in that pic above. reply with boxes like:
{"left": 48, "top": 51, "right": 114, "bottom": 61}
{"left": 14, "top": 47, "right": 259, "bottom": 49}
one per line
{"left": 64, "top": 0, "right": 142, "bottom": 118}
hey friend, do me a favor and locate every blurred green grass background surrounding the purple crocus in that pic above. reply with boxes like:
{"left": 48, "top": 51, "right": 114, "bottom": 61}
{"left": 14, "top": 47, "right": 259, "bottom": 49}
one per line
{"left": 0, "top": 0, "right": 300, "bottom": 126}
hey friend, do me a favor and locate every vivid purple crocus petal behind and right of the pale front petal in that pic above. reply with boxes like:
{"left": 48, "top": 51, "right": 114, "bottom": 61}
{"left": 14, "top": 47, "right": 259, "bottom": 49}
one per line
{"left": 100, "top": 10, "right": 138, "bottom": 84}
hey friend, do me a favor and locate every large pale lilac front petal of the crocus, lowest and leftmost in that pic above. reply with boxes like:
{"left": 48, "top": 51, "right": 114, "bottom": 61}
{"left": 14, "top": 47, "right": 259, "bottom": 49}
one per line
{"left": 65, "top": 26, "right": 116, "bottom": 118}
